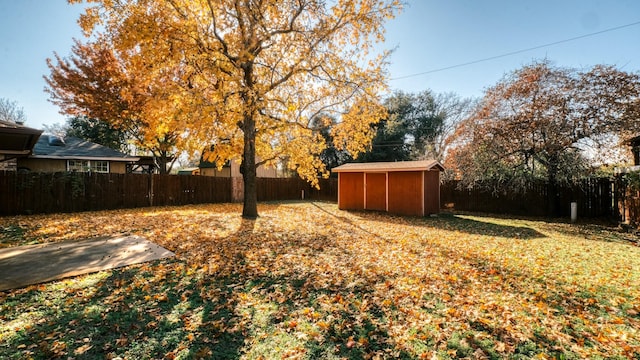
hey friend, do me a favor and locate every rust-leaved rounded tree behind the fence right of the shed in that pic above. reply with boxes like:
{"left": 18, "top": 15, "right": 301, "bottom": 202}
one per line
{"left": 447, "top": 62, "right": 640, "bottom": 213}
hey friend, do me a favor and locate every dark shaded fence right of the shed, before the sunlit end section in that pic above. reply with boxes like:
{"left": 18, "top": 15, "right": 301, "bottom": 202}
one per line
{"left": 440, "top": 178, "right": 618, "bottom": 218}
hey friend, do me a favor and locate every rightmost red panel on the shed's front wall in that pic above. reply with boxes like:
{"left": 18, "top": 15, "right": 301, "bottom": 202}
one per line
{"left": 389, "top": 171, "right": 424, "bottom": 216}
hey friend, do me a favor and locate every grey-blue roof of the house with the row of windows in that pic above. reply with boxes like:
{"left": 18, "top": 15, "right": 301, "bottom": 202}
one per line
{"left": 31, "top": 135, "right": 139, "bottom": 162}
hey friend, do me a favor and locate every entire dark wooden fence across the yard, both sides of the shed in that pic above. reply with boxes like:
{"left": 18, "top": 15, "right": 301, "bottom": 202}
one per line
{"left": 0, "top": 171, "right": 640, "bottom": 219}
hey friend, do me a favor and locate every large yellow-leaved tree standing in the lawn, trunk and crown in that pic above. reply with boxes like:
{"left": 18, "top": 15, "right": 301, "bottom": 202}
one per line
{"left": 57, "top": 0, "right": 401, "bottom": 218}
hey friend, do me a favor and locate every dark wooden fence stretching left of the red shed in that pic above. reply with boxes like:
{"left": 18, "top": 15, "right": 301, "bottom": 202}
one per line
{"left": 0, "top": 171, "right": 338, "bottom": 215}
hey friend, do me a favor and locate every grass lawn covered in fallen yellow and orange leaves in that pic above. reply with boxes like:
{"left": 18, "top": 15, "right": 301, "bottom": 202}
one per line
{"left": 0, "top": 203, "right": 640, "bottom": 359}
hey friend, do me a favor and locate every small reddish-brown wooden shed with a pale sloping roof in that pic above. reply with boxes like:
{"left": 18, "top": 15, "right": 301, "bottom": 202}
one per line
{"left": 332, "top": 160, "right": 444, "bottom": 216}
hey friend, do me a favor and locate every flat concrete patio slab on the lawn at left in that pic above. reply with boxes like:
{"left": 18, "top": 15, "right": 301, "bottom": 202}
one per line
{"left": 0, "top": 236, "right": 175, "bottom": 291}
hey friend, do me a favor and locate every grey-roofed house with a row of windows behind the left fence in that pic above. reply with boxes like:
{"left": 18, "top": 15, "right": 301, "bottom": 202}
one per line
{"left": 18, "top": 135, "right": 139, "bottom": 174}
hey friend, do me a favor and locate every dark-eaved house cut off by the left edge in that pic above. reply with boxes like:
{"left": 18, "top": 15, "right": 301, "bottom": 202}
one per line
{"left": 0, "top": 120, "right": 42, "bottom": 170}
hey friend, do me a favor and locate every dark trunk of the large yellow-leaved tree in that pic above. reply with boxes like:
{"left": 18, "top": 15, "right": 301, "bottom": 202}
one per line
{"left": 241, "top": 116, "right": 258, "bottom": 219}
